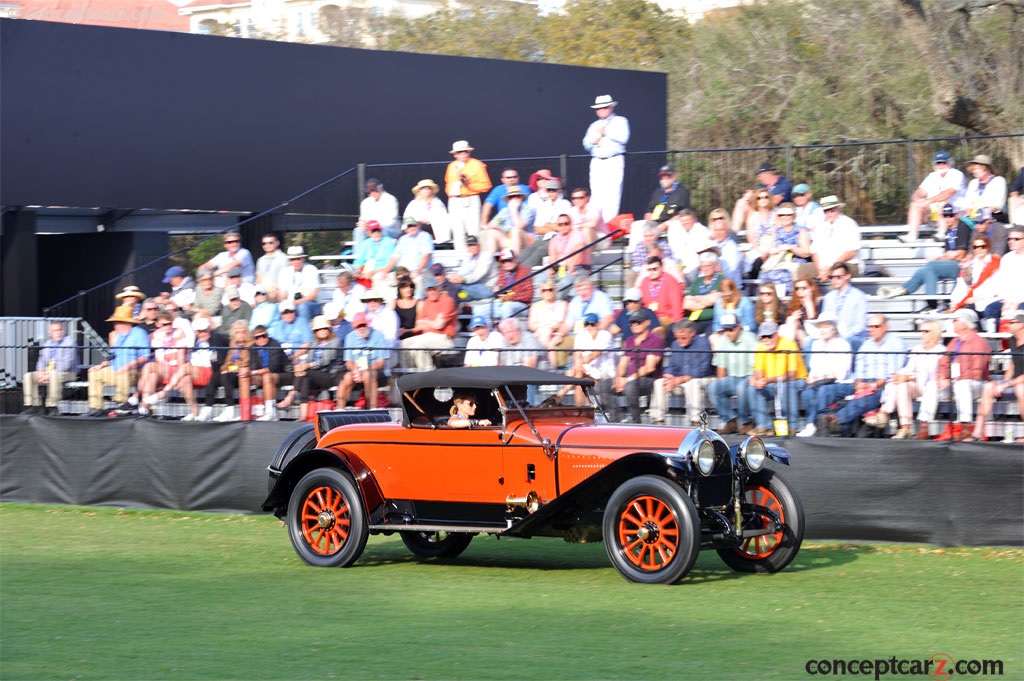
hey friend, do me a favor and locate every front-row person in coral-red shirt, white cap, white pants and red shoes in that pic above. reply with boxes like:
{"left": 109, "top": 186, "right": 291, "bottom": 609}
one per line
{"left": 918, "top": 309, "right": 992, "bottom": 440}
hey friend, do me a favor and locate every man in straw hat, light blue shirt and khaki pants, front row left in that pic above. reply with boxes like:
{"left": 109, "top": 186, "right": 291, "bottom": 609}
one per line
{"left": 85, "top": 305, "right": 150, "bottom": 417}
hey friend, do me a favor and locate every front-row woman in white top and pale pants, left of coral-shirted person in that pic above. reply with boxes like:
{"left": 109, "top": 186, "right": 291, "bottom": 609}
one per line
{"left": 864, "top": 322, "right": 945, "bottom": 439}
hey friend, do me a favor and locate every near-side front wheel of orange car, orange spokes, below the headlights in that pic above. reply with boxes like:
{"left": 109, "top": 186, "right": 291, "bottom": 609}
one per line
{"left": 603, "top": 475, "right": 700, "bottom": 584}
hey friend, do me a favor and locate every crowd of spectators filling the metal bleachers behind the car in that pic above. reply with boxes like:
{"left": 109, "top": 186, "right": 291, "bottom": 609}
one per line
{"left": 24, "top": 114, "right": 1024, "bottom": 440}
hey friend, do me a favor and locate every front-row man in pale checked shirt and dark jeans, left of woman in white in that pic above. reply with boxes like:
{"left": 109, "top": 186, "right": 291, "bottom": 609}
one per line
{"left": 818, "top": 313, "right": 906, "bottom": 437}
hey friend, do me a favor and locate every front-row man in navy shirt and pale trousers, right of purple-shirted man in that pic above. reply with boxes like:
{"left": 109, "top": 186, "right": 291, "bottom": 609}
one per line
{"left": 650, "top": 320, "right": 714, "bottom": 426}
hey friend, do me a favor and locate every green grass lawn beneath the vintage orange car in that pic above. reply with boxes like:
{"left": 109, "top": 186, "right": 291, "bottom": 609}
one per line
{"left": 0, "top": 504, "right": 1024, "bottom": 681}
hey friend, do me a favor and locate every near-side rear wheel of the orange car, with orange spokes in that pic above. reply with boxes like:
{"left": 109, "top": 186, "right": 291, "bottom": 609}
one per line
{"left": 286, "top": 468, "right": 370, "bottom": 567}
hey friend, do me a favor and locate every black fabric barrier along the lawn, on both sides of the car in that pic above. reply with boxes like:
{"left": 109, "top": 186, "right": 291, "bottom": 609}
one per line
{"left": 0, "top": 416, "right": 1024, "bottom": 546}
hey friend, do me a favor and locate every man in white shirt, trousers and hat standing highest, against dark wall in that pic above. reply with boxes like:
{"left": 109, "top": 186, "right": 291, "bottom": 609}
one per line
{"left": 583, "top": 94, "right": 630, "bottom": 222}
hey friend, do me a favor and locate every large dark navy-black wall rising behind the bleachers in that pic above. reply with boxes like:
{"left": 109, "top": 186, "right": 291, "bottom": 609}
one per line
{"left": 0, "top": 19, "right": 667, "bottom": 211}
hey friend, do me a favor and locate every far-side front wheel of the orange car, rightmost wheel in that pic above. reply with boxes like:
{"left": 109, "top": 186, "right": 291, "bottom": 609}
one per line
{"left": 718, "top": 470, "right": 804, "bottom": 572}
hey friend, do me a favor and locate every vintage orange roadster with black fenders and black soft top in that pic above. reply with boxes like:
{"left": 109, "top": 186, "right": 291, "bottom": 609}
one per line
{"left": 263, "top": 367, "right": 804, "bottom": 583}
